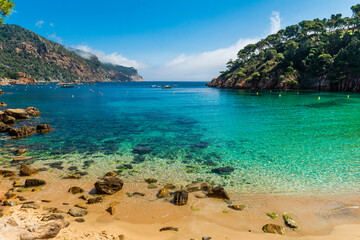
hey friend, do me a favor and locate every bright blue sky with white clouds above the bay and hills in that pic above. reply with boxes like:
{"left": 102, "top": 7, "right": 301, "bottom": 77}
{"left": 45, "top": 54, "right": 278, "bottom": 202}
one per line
{"left": 5, "top": 0, "right": 359, "bottom": 81}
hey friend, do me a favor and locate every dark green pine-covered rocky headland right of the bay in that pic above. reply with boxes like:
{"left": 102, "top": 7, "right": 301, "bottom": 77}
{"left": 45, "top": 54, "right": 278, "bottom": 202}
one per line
{"left": 207, "top": 4, "right": 360, "bottom": 92}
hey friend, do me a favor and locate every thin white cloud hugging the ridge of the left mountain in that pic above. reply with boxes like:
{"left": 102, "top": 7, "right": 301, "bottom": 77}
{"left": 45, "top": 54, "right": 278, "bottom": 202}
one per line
{"left": 75, "top": 45, "right": 146, "bottom": 69}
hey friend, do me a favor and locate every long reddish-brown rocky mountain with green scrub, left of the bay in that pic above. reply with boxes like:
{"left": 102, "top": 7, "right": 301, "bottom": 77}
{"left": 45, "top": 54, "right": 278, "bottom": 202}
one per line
{"left": 0, "top": 24, "right": 143, "bottom": 82}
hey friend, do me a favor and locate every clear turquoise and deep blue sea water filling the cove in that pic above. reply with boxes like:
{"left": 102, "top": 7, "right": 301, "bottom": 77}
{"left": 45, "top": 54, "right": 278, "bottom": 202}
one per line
{"left": 1, "top": 82, "right": 360, "bottom": 195}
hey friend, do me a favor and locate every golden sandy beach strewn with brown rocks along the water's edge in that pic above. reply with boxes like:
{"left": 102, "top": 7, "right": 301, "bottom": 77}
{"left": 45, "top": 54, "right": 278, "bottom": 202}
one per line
{"left": 0, "top": 172, "right": 360, "bottom": 240}
